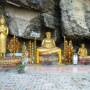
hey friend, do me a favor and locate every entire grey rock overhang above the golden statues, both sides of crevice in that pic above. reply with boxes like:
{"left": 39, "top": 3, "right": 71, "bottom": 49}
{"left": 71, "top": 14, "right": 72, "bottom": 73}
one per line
{"left": 1, "top": 0, "right": 90, "bottom": 40}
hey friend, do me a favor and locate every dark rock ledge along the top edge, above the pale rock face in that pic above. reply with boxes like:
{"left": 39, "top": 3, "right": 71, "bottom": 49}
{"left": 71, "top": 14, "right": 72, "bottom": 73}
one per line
{"left": 6, "top": 0, "right": 55, "bottom": 12}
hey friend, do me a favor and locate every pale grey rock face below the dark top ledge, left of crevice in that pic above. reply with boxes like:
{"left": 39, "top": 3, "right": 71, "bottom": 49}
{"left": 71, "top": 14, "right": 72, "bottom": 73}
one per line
{"left": 5, "top": 5, "right": 59, "bottom": 39}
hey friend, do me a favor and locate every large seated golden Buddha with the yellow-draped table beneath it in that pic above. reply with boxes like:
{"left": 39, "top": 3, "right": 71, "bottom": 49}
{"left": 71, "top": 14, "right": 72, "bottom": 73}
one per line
{"left": 37, "top": 32, "right": 61, "bottom": 63}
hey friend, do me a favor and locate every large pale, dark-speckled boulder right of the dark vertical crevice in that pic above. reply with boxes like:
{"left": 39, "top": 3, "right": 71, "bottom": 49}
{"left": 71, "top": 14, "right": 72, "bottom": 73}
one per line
{"left": 60, "top": 0, "right": 90, "bottom": 37}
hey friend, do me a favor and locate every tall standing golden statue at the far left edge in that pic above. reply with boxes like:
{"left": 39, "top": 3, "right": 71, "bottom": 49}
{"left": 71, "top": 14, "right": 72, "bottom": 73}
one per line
{"left": 0, "top": 16, "right": 9, "bottom": 56}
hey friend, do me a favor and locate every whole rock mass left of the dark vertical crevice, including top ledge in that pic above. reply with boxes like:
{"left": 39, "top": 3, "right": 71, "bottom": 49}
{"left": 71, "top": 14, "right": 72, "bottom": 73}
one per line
{"left": 5, "top": 0, "right": 61, "bottom": 40}
